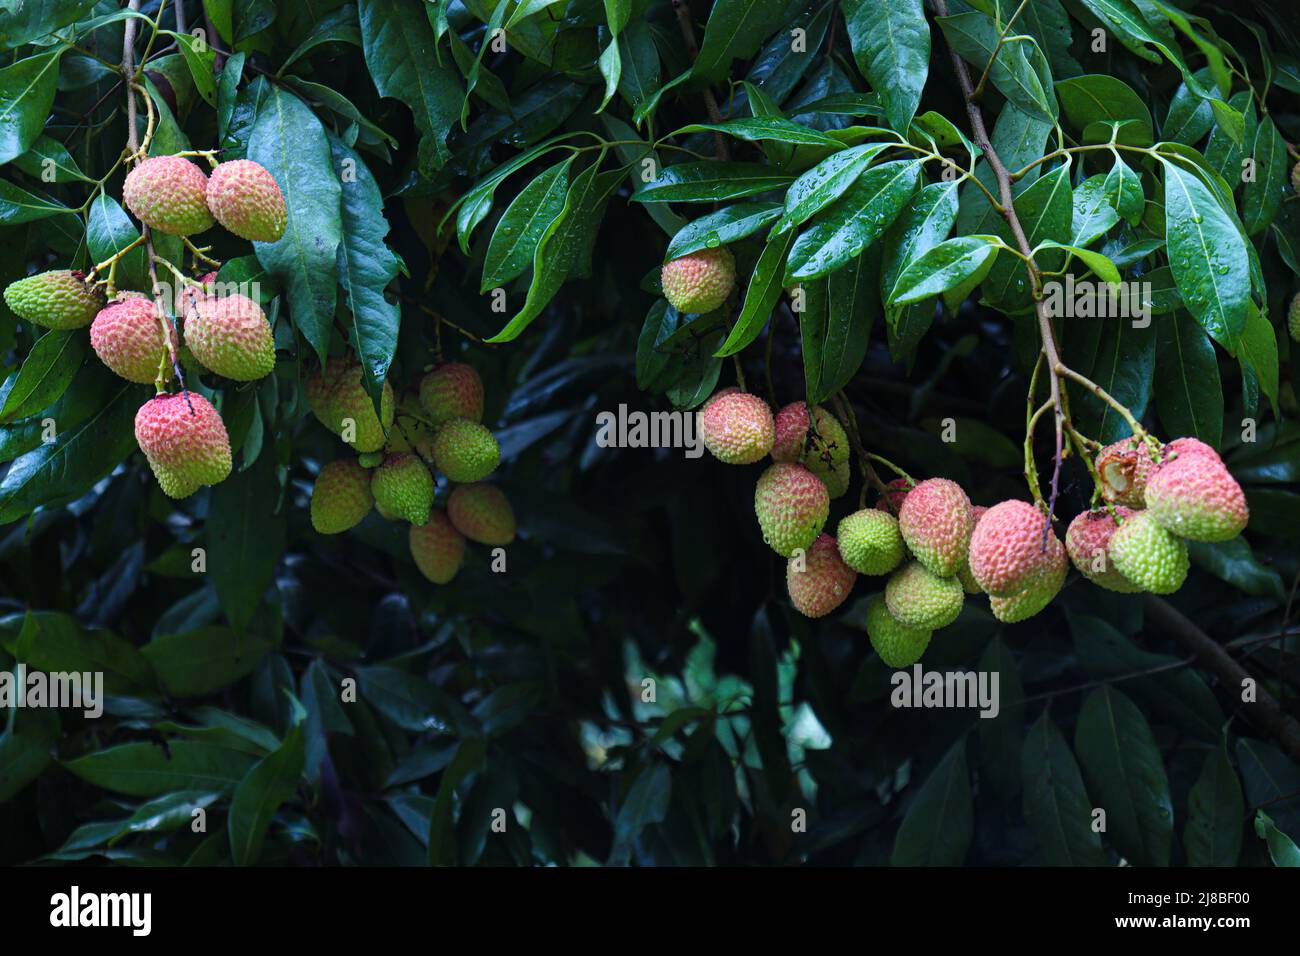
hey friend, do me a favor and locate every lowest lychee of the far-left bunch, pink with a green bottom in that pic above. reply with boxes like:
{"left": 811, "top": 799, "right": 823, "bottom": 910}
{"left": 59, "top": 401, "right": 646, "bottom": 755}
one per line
{"left": 135, "top": 392, "right": 230, "bottom": 498}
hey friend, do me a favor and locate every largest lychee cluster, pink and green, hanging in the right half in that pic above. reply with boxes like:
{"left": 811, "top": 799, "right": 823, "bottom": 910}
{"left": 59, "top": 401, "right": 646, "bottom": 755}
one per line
{"left": 699, "top": 389, "right": 1249, "bottom": 667}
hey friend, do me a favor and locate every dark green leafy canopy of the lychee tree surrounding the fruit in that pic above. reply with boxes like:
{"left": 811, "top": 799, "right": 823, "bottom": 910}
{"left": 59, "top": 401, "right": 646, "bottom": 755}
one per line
{"left": 0, "top": 0, "right": 1300, "bottom": 865}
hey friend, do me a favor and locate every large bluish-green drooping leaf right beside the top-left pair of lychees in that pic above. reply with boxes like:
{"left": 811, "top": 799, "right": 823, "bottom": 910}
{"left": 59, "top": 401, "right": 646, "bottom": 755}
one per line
{"left": 248, "top": 87, "right": 343, "bottom": 364}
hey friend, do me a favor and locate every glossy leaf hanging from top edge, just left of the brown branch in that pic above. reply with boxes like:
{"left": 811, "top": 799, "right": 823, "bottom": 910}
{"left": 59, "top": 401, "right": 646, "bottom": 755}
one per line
{"left": 844, "top": 0, "right": 930, "bottom": 133}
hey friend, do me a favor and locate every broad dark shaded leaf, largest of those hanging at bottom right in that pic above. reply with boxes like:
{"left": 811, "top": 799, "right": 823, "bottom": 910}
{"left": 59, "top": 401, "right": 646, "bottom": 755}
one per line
{"left": 1074, "top": 687, "right": 1174, "bottom": 866}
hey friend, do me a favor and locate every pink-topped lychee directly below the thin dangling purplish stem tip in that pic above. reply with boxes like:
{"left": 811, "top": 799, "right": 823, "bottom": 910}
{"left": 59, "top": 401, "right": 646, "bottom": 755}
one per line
{"left": 972, "top": 498, "right": 1066, "bottom": 597}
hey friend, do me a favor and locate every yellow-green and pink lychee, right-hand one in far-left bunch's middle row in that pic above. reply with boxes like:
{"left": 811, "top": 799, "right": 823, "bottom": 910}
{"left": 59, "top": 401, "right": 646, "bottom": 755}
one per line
{"left": 185, "top": 294, "right": 276, "bottom": 381}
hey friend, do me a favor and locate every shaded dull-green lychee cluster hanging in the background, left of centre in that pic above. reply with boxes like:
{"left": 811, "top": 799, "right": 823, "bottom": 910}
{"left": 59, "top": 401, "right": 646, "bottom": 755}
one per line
{"left": 307, "top": 359, "right": 515, "bottom": 584}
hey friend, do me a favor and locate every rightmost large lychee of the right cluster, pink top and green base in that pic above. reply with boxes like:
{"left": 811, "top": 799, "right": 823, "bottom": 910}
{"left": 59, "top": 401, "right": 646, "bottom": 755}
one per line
{"left": 1147, "top": 438, "right": 1251, "bottom": 541}
